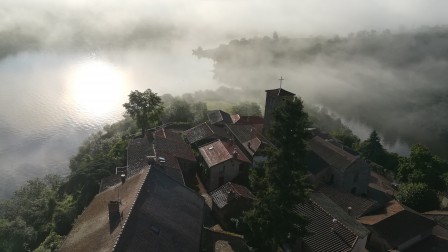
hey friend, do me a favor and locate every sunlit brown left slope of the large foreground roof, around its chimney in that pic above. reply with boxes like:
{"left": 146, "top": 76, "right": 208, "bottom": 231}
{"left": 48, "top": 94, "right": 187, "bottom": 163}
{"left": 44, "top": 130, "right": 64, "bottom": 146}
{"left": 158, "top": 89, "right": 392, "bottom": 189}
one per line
{"left": 58, "top": 169, "right": 148, "bottom": 252}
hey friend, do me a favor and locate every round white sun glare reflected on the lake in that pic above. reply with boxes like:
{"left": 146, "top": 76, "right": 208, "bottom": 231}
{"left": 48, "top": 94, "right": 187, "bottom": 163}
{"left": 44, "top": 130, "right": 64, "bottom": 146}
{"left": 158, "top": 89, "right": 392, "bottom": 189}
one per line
{"left": 68, "top": 60, "right": 128, "bottom": 117}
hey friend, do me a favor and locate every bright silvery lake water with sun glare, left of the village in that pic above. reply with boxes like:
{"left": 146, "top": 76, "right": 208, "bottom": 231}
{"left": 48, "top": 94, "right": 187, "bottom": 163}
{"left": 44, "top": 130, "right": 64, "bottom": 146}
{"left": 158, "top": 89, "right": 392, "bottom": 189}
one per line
{"left": 0, "top": 51, "right": 217, "bottom": 198}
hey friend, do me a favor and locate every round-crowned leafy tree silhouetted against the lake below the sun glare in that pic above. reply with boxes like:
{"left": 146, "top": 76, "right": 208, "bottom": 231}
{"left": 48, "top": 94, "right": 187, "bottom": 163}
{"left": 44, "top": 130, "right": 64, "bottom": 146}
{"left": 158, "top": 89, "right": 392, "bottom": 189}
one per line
{"left": 123, "top": 88, "right": 163, "bottom": 135}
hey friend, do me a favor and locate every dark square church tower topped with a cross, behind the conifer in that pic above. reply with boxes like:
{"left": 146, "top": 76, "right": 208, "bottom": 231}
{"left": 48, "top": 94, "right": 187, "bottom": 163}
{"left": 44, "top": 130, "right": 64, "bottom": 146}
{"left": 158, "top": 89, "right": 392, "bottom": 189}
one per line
{"left": 263, "top": 77, "right": 296, "bottom": 134}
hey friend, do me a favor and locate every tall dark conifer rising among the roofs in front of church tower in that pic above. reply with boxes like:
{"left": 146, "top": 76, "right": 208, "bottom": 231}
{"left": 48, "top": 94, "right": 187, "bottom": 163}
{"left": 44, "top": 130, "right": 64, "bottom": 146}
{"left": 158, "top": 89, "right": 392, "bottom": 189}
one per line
{"left": 243, "top": 98, "right": 309, "bottom": 251}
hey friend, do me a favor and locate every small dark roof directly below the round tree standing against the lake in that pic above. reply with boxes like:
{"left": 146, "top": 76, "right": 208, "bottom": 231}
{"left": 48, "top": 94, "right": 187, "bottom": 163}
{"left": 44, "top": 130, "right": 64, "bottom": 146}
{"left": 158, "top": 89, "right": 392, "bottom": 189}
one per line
{"left": 127, "top": 136, "right": 152, "bottom": 177}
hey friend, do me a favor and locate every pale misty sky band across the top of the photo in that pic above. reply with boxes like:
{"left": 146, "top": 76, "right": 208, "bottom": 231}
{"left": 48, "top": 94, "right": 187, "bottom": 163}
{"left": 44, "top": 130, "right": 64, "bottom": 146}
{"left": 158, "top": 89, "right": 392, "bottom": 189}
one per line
{"left": 0, "top": 0, "right": 448, "bottom": 56}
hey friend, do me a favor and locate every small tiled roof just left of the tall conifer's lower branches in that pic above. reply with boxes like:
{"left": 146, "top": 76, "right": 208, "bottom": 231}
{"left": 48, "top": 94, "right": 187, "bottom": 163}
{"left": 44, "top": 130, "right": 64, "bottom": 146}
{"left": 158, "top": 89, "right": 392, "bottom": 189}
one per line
{"left": 210, "top": 182, "right": 255, "bottom": 208}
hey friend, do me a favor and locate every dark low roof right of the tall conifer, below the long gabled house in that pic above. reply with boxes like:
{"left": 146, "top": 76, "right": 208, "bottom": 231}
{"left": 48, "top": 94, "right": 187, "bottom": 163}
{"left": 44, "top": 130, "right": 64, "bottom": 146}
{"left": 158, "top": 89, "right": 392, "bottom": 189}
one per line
{"left": 317, "top": 186, "right": 381, "bottom": 218}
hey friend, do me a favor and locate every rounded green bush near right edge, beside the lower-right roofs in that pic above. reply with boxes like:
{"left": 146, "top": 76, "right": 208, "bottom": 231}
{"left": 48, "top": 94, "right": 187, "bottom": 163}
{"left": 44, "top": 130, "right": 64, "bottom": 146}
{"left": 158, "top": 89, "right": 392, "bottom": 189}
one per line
{"left": 397, "top": 183, "right": 439, "bottom": 212}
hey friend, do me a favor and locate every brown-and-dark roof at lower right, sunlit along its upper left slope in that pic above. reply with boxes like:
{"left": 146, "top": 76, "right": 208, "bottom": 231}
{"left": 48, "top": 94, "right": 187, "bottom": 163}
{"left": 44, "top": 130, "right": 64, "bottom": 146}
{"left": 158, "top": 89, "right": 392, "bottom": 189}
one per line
{"left": 359, "top": 200, "right": 436, "bottom": 248}
